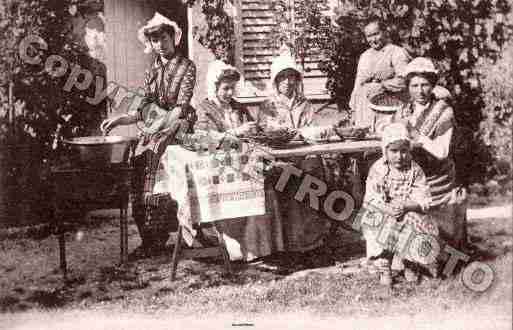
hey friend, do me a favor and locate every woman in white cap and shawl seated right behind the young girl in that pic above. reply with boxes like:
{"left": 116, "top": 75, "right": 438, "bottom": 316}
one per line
{"left": 393, "top": 57, "right": 466, "bottom": 248}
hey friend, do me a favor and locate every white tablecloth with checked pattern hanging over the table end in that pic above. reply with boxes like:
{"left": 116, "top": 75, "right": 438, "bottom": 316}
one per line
{"left": 154, "top": 145, "right": 265, "bottom": 232}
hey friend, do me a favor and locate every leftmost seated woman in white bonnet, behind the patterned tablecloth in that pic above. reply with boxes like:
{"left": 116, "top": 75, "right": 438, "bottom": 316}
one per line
{"left": 195, "top": 61, "right": 283, "bottom": 261}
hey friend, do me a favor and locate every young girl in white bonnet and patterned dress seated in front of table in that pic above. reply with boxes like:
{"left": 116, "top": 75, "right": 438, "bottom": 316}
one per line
{"left": 361, "top": 123, "right": 438, "bottom": 285}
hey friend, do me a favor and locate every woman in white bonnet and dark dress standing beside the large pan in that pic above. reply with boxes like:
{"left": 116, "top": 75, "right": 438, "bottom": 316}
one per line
{"left": 101, "top": 13, "right": 196, "bottom": 257}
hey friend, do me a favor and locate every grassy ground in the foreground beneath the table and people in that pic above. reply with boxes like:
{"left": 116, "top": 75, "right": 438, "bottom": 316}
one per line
{"left": 0, "top": 196, "right": 513, "bottom": 329}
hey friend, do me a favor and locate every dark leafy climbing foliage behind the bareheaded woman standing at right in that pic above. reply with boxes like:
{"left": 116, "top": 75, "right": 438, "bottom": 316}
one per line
{"left": 308, "top": 0, "right": 511, "bottom": 183}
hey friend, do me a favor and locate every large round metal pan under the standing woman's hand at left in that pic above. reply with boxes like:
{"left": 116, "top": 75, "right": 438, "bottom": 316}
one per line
{"left": 64, "top": 135, "right": 137, "bottom": 166}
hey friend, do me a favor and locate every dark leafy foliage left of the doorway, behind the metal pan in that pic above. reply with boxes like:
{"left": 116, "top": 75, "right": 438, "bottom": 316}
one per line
{"left": 0, "top": 0, "right": 104, "bottom": 159}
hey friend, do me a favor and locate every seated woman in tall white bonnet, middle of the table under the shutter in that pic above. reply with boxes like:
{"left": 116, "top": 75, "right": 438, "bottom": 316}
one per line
{"left": 259, "top": 54, "right": 329, "bottom": 256}
